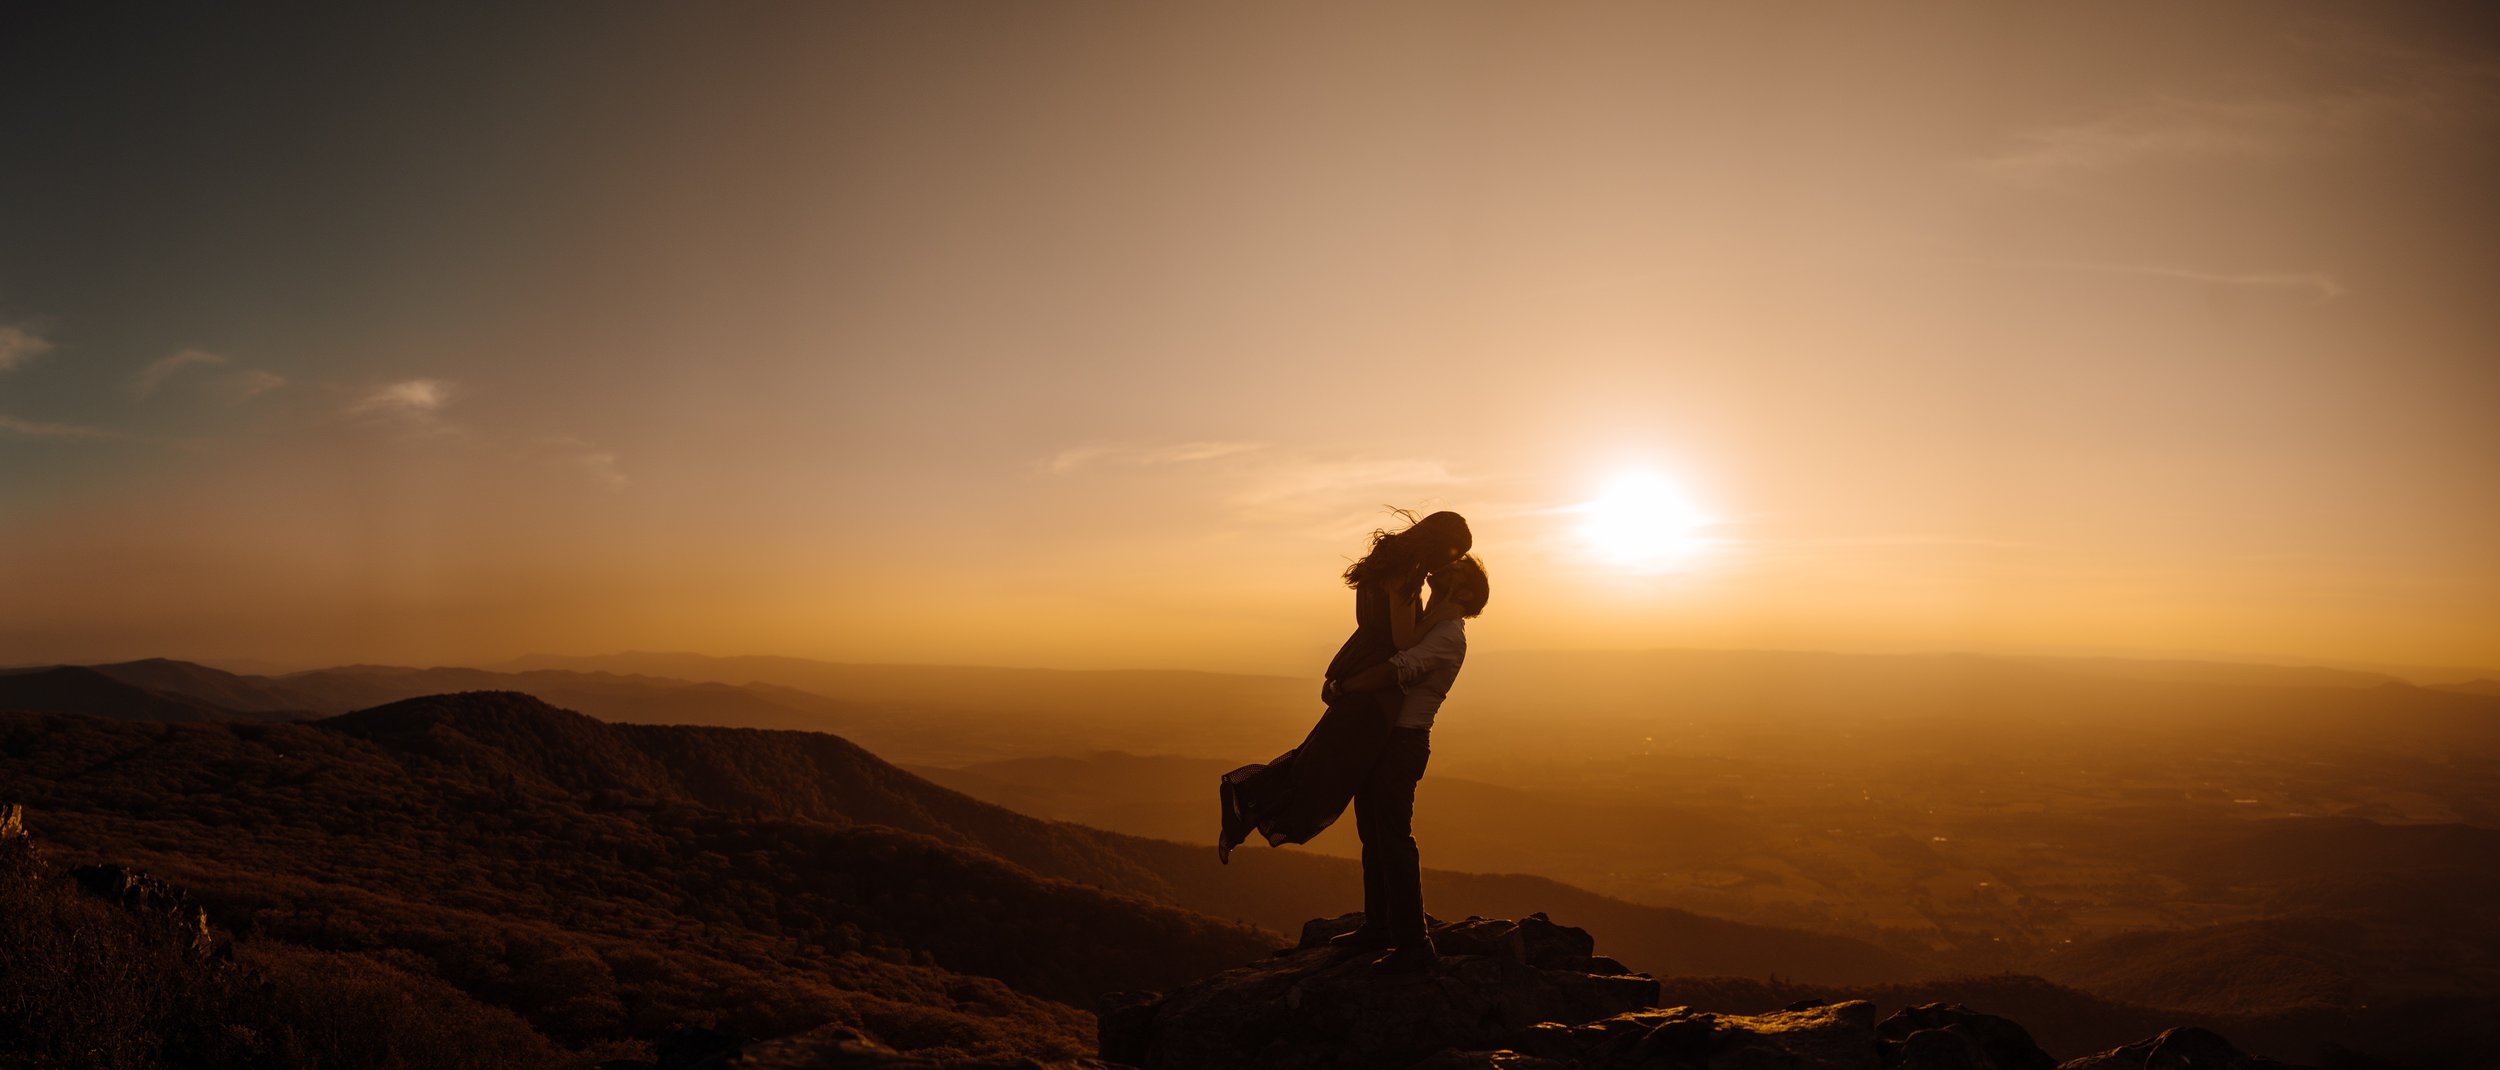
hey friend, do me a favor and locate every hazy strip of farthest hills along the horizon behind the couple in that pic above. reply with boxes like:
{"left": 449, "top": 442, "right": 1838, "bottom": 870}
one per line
{"left": 0, "top": 650, "right": 2500, "bottom": 768}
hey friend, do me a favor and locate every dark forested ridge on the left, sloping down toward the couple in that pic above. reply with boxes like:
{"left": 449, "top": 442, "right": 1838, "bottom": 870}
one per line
{"left": 0, "top": 695, "right": 1275, "bottom": 1055}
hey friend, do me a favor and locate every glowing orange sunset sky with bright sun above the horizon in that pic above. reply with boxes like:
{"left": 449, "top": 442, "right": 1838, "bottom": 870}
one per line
{"left": 0, "top": 3, "right": 2500, "bottom": 673}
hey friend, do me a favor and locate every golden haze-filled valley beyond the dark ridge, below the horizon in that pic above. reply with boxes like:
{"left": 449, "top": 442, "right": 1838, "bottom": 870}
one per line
{"left": 0, "top": 650, "right": 2500, "bottom": 1058}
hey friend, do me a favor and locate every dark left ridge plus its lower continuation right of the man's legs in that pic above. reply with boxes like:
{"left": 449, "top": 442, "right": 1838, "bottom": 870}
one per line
{"left": 0, "top": 693, "right": 1910, "bottom": 1058}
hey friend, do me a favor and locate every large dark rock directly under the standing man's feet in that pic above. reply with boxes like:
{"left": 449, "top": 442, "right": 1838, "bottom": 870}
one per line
{"left": 1100, "top": 915, "right": 1658, "bottom": 1070}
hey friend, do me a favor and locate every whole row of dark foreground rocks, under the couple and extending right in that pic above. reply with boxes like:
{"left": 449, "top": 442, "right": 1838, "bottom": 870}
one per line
{"left": 1100, "top": 915, "right": 2290, "bottom": 1070}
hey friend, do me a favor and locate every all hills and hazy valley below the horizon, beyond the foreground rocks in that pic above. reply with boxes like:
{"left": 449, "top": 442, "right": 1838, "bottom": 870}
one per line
{"left": 0, "top": 653, "right": 2500, "bottom": 1055}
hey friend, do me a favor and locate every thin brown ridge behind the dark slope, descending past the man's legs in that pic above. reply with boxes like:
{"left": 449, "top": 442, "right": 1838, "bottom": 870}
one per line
{"left": 0, "top": 680, "right": 1920, "bottom": 980}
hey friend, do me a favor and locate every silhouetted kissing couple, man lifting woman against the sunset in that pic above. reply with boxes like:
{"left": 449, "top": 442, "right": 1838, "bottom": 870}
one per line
{"left": 1215, "top": 513, "right": 1493, "bottom": 970}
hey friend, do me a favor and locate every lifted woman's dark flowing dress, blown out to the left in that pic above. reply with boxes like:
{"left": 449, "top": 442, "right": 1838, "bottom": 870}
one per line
{"left": 1223, "top": 585, "right": 1400, "bottom": 848}
